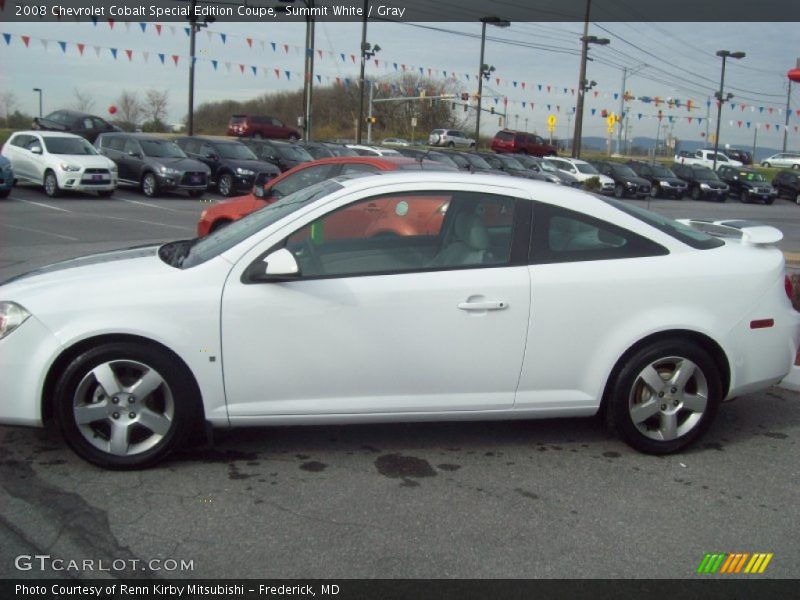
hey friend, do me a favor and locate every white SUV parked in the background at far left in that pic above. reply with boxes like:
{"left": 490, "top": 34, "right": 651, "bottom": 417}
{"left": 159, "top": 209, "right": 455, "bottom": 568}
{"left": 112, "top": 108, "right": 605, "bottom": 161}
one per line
{"left": 2, "top": 131, "right": 118, "bottom": 197}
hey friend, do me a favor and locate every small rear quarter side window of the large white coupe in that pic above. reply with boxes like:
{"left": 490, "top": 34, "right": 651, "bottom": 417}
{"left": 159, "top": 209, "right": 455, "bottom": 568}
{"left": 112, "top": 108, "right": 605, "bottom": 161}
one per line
{"left": 530, "top": 204, "right": 669, "bottom": 264}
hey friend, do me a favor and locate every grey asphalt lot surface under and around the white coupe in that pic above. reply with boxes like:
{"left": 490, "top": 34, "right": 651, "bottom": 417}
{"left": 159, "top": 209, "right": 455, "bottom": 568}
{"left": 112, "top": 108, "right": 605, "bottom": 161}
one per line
{"left": 0, "top": 182, "right": 800, "bottom": 577}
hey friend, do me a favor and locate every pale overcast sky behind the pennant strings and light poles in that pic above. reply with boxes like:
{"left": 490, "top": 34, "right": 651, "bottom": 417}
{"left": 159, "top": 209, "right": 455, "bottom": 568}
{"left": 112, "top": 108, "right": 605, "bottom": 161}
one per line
{"left": 0, "top": 21, "right": 800, "bottom": 150}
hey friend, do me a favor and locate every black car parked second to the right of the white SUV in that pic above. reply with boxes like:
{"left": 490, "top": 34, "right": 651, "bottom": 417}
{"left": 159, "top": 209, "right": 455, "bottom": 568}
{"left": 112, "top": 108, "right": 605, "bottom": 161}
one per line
{"left": 175, "top": 137, "right": 281, "bottom": 196}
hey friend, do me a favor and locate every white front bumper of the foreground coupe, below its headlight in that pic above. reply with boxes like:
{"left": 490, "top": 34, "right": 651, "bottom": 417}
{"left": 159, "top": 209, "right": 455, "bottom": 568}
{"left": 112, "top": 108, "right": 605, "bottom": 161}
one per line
{"left": 0, "top": 316, "right": 62, "bottom": 426}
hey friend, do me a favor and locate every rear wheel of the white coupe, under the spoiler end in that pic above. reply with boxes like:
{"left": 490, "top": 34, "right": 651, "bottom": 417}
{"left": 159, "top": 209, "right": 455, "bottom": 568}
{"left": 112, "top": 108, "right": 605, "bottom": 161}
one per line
{"left": 605, "top": 338, "right": 722, "bottom": 454}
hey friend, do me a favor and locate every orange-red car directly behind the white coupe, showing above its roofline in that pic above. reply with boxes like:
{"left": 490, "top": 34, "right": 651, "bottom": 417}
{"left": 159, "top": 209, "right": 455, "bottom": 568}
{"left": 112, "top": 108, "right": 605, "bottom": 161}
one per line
{"left": 197, "top": 156, "right": 455, "bottom": 237}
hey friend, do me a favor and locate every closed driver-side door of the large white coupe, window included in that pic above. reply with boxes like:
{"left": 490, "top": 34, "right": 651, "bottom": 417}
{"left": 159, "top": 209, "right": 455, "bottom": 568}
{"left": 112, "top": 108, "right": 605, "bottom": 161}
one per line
{"left": 222, "top": 185, "right": 530, "bottom": 418}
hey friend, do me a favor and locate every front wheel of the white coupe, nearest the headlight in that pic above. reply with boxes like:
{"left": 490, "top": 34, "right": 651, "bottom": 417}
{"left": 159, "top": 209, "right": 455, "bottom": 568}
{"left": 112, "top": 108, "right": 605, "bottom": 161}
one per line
{"left": 54, "top": 342, "right": 198, "bottom": 469}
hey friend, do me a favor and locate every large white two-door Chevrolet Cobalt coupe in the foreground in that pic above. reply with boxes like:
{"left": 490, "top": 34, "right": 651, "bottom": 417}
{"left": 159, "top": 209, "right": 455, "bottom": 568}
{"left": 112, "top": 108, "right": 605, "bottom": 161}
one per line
{"left": 0, "top": 172, "right": 800, "bottom": 469}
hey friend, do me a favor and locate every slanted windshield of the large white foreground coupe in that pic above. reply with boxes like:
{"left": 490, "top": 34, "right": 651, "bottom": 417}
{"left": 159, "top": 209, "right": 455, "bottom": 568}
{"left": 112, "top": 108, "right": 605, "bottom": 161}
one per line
{"left": 178, "top": 179, "right": 342, "bottom": 269}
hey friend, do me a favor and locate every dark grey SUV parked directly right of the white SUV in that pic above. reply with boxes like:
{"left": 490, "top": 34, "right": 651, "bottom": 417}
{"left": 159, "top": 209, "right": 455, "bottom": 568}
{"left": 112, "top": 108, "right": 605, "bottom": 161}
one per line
{"left": 95, "top": 133, "right": 210, "bottom": 198}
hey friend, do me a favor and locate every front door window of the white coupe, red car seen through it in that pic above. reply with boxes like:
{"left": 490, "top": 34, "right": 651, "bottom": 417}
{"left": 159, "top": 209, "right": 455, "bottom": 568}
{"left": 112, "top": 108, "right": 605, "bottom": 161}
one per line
{"left": 284, "top": 192, "right": 516, "bottom": 278}
